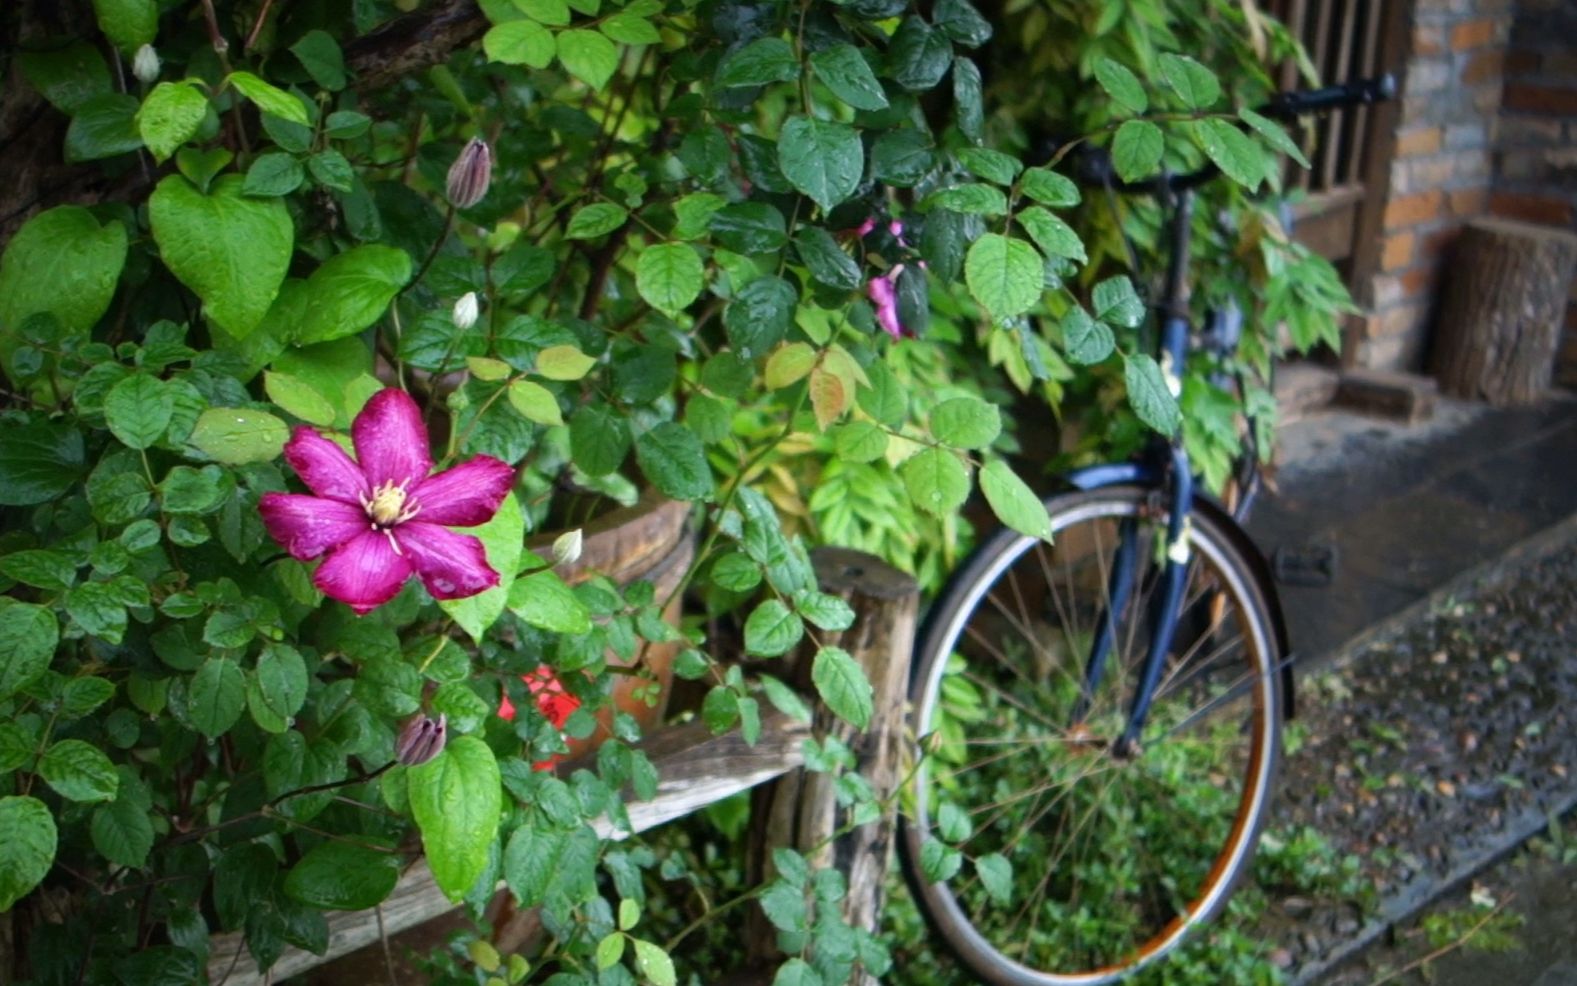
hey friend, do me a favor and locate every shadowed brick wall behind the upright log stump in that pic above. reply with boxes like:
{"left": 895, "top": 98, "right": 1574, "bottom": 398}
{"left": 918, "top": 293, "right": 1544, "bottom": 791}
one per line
{"left": 1489, "top": 0, "right": 1577, "bottom": 387}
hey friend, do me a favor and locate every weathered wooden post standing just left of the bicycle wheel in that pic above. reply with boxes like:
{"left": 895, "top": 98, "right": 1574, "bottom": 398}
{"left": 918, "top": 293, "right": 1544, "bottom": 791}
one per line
{"left": 746, "top": 547, "right": 919, "bottom": 984}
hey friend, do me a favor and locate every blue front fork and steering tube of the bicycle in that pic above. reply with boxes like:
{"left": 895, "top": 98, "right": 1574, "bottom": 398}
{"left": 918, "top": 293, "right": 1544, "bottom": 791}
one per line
{"left": 1069, "top": 188, "right": 1194, "bottom": 754}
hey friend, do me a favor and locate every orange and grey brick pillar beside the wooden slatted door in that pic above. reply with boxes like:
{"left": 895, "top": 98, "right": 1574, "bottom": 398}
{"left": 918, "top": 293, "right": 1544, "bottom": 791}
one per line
{"left": 1348, "top": 0, "right": 1513, "bottom": 369}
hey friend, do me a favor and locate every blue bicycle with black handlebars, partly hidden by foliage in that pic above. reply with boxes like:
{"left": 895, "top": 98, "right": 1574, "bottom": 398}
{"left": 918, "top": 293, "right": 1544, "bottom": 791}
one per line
{"left": 899, "top": 76, "right": 1394, "bottom": 986}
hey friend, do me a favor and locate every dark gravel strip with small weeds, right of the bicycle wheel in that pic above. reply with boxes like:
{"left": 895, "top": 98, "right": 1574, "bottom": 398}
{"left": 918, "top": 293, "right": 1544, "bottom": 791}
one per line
{"left": 1266, "top": 536, "right": 1577, "bottom": 986}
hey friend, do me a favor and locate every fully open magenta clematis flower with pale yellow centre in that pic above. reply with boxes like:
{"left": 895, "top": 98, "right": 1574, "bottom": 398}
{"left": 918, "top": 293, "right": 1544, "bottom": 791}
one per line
{"left": 257, "top": 388, "right": 514, "bottom": 615}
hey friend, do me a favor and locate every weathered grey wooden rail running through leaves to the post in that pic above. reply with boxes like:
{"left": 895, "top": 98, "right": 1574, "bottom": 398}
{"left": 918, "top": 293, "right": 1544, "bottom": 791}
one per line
{"left": 208, "top": 710, "right": 811, "bottom": 986}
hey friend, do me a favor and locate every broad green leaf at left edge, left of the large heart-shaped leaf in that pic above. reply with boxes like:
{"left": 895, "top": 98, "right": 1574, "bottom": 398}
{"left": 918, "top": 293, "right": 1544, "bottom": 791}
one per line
{"left": 0, "top": 208, "right": 124, "bottom": 366}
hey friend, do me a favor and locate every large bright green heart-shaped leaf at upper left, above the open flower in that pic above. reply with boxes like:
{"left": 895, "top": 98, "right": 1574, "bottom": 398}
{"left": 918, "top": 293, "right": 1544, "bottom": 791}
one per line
{"left": 148, "top": 175, "right": 296, "bottom": 339}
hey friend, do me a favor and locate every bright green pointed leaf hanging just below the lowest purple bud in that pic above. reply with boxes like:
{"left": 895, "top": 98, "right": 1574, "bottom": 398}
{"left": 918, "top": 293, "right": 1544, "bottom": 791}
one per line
{"left": 405, "top": 737, "right": 503, "bottom": 901}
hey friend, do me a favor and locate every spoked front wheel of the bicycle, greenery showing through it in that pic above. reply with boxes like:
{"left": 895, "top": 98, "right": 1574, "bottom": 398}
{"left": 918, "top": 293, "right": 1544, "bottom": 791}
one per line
{"left": 899, "top": 486, "right": 1282, "bottom": 986}
